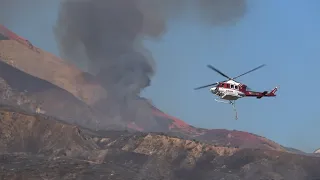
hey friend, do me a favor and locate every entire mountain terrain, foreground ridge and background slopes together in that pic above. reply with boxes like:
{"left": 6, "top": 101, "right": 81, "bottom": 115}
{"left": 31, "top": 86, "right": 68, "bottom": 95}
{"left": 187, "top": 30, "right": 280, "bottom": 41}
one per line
{"left": 0, "top": 26, "right": 320, "bottom": 180}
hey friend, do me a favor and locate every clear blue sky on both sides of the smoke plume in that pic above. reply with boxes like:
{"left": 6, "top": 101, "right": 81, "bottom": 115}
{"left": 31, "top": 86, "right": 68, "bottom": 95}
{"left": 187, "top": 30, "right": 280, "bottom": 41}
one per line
{"left": 0, "top": 0, "right": 320, "bottom": 152}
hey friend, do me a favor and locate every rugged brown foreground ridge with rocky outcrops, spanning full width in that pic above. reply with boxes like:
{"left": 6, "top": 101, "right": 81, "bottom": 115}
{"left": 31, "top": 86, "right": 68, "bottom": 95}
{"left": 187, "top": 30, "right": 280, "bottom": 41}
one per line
{"left": 0, "top": 106, "right": 320, "bottom": 180}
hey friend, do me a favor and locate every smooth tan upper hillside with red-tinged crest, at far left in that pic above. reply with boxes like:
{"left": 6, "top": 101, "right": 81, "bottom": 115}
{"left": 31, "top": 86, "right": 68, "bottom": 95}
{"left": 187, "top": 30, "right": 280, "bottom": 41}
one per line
{"left": 0, "top": 25, "right": 106, "bottom": 105}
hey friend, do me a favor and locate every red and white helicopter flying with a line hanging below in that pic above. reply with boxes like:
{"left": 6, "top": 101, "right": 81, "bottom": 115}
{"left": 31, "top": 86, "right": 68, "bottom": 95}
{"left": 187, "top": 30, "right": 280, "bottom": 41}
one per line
{"left": 195, "top": 64, "right": 278, "bottom": 119}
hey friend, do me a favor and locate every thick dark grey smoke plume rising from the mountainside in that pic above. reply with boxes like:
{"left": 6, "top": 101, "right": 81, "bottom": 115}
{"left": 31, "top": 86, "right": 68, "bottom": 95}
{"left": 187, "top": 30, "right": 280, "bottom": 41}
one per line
{"left": 54, "top": 0, "right": 245, "bottom": 129}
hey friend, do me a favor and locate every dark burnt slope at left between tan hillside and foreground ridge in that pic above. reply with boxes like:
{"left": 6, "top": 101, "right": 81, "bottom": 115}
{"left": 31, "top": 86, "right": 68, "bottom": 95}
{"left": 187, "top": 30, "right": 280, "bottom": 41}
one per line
{"left": 0, "top": 59, "right": 100, "bottom": 128}
